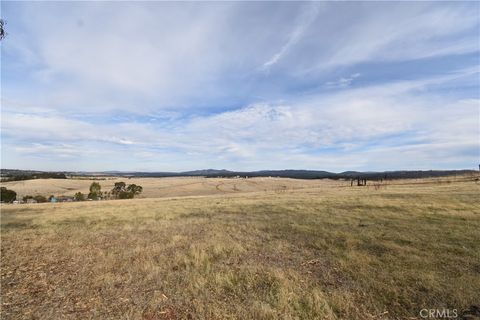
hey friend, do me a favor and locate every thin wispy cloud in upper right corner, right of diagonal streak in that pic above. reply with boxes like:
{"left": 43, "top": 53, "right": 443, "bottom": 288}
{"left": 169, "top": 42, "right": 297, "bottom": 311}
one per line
{"left": 286, "top": 2, "right": 479, "bottom": 75}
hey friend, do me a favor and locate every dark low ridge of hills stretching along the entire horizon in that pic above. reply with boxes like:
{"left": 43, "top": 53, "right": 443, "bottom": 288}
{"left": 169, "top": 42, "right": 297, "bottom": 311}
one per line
{"left": 1, "top": 169, "right": 478, "bottom": 181}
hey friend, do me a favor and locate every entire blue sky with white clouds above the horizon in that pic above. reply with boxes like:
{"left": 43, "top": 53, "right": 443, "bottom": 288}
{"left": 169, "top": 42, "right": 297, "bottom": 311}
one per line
{"left": 1, "top": 1, "right": 480, "bottom": 172}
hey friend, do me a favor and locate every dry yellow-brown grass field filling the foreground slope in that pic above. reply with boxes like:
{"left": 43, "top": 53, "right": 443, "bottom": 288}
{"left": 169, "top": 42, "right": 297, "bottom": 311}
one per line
{"left": 1, "top": 179, "right": 480, "bottom": 319}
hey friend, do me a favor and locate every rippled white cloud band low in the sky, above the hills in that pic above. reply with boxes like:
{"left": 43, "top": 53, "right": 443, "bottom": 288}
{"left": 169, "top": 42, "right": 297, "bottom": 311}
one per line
{"left": 2, "top": 69, "right": 479, "bottom": 171}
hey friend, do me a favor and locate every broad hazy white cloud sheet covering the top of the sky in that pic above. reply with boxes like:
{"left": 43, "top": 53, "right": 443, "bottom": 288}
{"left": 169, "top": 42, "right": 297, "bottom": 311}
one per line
{"left": 2, "top": 2, "right": 478, "bottom": 114}
